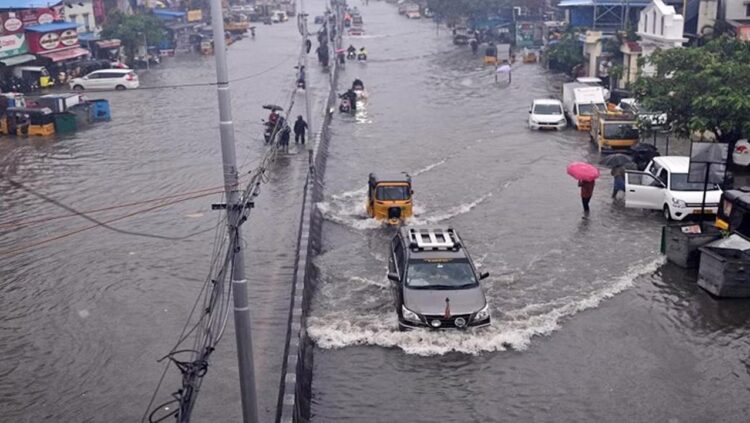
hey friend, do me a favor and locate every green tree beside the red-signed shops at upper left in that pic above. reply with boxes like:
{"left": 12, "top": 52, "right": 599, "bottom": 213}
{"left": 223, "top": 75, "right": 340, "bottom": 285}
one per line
{"left": 102, "top": 10, "right": 165, "bottom": 63}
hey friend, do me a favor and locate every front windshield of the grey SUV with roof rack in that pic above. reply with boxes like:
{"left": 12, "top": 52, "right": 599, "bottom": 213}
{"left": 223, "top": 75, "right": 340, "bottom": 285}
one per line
{"left": 406, "top": 259, "right": 478, "bottom": 289}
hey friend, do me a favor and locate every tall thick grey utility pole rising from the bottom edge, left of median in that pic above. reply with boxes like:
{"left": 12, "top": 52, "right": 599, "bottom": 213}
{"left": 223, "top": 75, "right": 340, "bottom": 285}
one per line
{"left": 211, "top": 0, "right": 258, "bottom": 423}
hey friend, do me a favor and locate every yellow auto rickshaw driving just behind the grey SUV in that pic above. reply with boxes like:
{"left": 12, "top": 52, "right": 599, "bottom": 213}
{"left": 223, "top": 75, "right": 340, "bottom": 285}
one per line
{"left": 367, "top": 173, "right": 414, "bottom": 225}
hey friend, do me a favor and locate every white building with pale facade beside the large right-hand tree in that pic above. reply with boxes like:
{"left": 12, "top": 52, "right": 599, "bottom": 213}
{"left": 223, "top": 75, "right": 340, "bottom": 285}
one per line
{"left": 638, "top": 0, "right": 687, "bottom": 75}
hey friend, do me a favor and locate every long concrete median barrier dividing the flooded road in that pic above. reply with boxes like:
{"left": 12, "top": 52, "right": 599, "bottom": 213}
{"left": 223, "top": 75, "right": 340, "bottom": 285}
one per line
{"left": 276, "top": 5, "right": 343, "bottom": 423}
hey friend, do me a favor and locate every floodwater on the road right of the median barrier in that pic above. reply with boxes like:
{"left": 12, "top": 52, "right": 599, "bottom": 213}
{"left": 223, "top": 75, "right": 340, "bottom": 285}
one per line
{"left": 308, "top": 2, "right": 750, "bottom": 422}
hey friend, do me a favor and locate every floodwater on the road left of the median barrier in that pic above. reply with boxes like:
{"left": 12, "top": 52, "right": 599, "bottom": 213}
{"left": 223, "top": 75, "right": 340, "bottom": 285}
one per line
{"left": 0, "top": 1, "right": 327, "bottom": 422}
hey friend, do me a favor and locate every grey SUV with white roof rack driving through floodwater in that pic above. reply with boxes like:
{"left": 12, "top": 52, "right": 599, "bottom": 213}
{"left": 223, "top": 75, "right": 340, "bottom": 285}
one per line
{"left": 388, "top": 227, "right": 490, "bottom": 330}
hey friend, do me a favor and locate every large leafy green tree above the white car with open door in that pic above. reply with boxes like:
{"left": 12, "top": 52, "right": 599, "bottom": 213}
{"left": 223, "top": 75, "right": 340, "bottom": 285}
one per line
{"left": 634, "top": 36, "right": 750, "bottom": 160}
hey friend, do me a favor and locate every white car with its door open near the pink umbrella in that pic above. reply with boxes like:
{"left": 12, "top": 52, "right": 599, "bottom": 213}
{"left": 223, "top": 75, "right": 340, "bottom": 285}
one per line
{"left": 625, "top": 156, "right": 721, "bottom": 220}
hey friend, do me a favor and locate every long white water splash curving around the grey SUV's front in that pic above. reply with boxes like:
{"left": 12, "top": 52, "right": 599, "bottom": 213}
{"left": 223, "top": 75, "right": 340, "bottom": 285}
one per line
{"left": 308, "top": 257, "right": 664, "bottom": 356}
